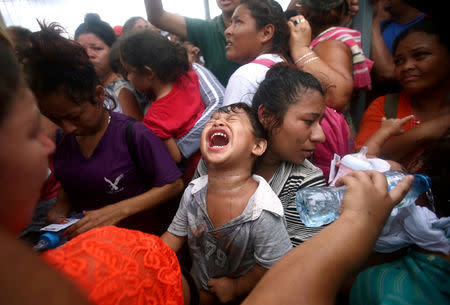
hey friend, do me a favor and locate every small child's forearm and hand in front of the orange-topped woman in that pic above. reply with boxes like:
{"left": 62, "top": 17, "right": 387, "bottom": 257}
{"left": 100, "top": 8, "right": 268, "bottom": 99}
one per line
{"left": 364, "top": 115, "right": 414, "bottom": 158}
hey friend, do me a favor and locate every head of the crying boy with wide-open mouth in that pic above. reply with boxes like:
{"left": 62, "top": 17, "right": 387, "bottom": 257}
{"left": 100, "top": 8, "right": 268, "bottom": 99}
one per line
{"left": 200, "top": 103, "right": 267, "bottom": 169}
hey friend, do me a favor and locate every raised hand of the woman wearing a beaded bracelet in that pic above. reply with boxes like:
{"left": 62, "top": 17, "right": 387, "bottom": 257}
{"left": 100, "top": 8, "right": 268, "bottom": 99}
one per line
{"left": 288, "top": 15, "right": 311, "bottom": 54}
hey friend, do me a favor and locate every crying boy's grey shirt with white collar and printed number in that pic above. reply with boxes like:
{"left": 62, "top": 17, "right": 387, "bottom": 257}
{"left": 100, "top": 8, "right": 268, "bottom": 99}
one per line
{"left": 168, "top": 175, "right": 292, "bottom": 290}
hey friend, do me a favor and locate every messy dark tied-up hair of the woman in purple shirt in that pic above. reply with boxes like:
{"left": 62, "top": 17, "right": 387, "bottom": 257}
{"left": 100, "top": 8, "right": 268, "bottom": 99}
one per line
{"left": 24, "top": 23, "right": 100, "bottom": 104}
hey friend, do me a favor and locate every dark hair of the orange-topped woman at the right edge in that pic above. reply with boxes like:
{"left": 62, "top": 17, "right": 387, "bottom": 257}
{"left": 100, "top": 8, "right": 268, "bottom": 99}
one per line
{"left": 392, "top": 17, "right": 450, "bottom": 54}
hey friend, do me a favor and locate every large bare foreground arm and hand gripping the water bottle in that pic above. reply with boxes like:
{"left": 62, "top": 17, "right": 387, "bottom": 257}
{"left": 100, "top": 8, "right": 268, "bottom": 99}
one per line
{"left": 243, "top": 171, "right": 413, "bottom": 305}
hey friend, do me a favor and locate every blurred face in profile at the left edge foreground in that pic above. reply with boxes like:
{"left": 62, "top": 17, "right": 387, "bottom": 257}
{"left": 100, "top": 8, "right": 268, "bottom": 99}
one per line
{"left": 0, "top": 88, "right": 55, "bottom": 234}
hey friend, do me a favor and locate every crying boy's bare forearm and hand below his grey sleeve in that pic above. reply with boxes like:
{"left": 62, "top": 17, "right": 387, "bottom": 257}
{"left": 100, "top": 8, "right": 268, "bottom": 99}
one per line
{"left": 208, "top": 264, "right": 267, "bottom": 303}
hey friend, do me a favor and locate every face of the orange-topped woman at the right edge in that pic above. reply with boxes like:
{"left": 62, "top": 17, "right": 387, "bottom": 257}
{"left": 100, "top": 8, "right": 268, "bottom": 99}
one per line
{"left": 394, "top": 32, "right": 450, "bottom": 94}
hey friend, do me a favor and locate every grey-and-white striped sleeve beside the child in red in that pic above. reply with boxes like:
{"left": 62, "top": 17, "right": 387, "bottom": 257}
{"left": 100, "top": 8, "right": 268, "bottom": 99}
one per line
{"left": 175, "top": 63, "right": 225, "bottom": 158}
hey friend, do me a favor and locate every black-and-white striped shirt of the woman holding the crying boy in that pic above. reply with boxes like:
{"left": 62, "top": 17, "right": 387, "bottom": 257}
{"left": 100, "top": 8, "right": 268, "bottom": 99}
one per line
{"left": 193, "top": 160, "right": 326, "bottom": 247}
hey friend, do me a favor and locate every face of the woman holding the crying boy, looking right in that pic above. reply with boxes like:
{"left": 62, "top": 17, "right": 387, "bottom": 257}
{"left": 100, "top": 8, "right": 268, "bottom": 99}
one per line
{"left": 267, "top": 90, "right": 325, "bottom": 164}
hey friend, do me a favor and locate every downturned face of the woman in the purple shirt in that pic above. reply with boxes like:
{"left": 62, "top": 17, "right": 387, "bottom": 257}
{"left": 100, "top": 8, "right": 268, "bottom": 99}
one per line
{"left": 39, "top": 86, "right": 106, "bottom": 136}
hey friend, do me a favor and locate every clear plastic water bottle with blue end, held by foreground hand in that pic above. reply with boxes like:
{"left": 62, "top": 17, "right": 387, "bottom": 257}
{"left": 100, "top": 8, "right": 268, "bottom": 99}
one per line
{"left": 295, "top": 170, "right": 431, "bottom": 227}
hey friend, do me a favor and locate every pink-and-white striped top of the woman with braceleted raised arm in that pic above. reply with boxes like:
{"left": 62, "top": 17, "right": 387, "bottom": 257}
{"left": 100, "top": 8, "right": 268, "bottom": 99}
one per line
{"left": 310, "top": 27, "right": 373, "bottom": 90}
